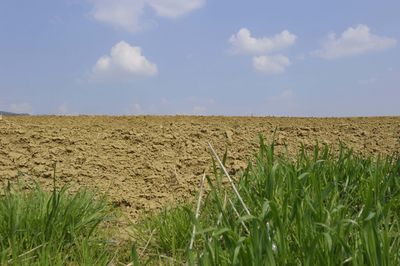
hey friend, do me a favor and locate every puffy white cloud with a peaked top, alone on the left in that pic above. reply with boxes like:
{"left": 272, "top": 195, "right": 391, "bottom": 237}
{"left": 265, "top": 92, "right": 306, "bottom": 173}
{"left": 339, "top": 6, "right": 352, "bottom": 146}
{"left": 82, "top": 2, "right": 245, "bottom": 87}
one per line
{"left": 92, "top": 41, "right": 158, "bottom": 80}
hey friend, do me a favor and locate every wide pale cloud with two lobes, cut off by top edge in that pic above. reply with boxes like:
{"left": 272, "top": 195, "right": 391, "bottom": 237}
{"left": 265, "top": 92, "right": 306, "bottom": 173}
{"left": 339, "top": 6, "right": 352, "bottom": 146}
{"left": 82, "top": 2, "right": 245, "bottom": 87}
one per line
{"left": 88, "top": 0, "right": 205, "bottom": 32}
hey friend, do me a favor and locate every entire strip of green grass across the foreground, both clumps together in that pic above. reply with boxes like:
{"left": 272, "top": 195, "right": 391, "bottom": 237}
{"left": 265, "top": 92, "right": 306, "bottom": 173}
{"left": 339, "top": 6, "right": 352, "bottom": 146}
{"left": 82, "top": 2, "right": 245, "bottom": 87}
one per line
{"left": 0, "top": 138, "right": 400, "bottom": 265}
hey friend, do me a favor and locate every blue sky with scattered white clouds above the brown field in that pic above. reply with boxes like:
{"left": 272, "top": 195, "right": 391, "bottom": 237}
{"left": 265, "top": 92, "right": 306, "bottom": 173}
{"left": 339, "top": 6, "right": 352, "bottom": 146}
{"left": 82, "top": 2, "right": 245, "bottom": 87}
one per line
{"left": 0, "top": 0, "right": 400, "bottom": 117}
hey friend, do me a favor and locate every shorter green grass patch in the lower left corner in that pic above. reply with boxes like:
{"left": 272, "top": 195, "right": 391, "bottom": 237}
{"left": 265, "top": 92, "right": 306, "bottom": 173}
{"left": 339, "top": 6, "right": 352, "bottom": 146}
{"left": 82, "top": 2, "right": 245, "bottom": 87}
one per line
{"left": 0, "top": 174, "right": 112, "bottom": 265}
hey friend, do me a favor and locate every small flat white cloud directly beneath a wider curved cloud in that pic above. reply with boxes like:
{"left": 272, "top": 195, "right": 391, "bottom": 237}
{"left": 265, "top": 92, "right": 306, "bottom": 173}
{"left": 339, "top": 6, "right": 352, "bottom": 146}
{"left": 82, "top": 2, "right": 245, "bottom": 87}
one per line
{"left": 253, "top": 55, "right": 291, "bottom": 74}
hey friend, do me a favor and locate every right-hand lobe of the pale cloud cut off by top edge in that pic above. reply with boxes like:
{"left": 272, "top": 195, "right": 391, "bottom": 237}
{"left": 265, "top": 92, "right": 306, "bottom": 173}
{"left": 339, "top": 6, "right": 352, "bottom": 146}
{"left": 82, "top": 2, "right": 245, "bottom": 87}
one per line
{"left": 147, "top": 0, "right": 205, "bottom": 18}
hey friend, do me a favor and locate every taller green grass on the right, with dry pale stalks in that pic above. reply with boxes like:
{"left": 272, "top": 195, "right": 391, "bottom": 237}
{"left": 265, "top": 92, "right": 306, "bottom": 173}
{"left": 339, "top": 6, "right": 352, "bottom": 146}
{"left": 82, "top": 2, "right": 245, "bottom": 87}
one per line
{"left": 136, "top": 138, "right": 400, "bottom": 265}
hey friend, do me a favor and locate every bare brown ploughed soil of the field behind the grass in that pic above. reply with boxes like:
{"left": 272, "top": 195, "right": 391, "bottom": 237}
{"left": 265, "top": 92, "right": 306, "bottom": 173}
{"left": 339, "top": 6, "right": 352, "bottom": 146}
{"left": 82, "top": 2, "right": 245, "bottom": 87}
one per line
{"left": 0, "top": 116, "right": 400, "bottom": 218}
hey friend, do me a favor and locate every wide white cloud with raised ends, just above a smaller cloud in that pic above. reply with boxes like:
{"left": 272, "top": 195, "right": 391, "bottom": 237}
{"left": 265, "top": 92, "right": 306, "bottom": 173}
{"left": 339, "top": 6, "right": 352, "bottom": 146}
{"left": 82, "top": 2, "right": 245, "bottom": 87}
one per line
{"left": 229, "top": 28, "right": 297, "bottom": 55}
